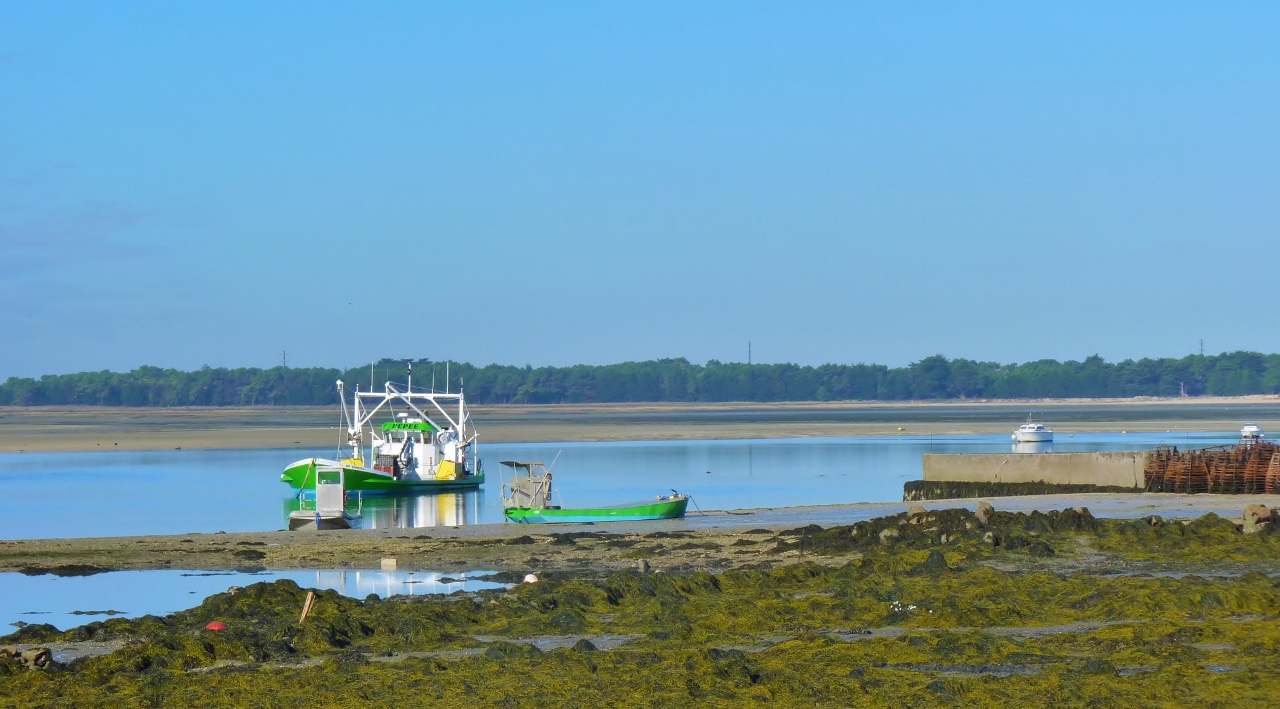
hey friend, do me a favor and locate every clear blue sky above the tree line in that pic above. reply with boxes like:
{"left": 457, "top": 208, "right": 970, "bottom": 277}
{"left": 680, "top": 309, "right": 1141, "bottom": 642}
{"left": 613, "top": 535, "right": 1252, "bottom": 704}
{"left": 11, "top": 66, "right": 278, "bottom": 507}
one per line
{"left": 0, "top": 0, "right": 1280, "bottom": 378}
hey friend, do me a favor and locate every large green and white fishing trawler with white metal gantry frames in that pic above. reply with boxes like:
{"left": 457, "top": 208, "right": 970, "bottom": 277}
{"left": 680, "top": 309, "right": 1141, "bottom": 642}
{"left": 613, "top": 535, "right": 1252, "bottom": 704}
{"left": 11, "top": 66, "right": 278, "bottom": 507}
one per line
{"left": 280, "top": 367, "right": 484, "bottom": 494}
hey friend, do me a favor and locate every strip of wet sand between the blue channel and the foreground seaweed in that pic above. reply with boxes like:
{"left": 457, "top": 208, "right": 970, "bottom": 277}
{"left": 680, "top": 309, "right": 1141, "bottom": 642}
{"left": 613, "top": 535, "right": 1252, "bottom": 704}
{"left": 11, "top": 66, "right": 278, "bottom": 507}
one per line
{"left": 0, "top": 493, "right": 1280, "bottom": 575}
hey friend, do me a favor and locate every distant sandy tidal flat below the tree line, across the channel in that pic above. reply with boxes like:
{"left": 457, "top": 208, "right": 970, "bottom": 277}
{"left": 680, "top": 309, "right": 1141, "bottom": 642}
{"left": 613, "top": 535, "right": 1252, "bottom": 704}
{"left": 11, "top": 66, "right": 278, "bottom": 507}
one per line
{"left": 0, "top": 397, "right": 1280, "bottom": 453}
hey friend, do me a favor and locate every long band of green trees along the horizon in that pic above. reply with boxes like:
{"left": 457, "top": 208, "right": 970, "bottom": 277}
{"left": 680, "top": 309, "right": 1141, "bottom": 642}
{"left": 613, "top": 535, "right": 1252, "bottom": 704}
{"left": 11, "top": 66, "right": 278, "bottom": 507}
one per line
{"left": 0, "top": 352, "right": 1280, "bottom": 406}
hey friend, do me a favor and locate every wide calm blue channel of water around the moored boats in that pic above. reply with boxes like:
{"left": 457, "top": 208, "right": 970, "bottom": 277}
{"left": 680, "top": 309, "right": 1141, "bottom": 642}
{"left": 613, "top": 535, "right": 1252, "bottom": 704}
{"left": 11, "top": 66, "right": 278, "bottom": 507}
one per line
{"left": 0, "top": 431, "right": 1239, "bottom": 537}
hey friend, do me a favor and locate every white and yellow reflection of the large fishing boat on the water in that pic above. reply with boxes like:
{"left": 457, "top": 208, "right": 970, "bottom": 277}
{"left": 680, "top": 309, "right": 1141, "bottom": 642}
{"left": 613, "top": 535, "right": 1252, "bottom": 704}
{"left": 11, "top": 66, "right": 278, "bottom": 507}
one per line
{"left": 284, "top": 490, "right": 484, "bottom": 530}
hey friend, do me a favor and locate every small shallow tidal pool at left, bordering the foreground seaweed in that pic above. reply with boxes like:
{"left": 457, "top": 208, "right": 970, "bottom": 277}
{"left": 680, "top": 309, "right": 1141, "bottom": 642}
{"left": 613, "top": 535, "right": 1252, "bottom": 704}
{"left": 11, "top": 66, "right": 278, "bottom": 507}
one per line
{"left": 0, "top": 570, "right": 502, "bottom": 635}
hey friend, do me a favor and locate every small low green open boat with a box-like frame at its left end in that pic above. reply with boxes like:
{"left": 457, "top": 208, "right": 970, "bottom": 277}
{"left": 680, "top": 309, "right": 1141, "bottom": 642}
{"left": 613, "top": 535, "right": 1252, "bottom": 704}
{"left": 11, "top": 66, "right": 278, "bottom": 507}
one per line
{"left": 502, "top": 461, "right": 689, "bottom": 525}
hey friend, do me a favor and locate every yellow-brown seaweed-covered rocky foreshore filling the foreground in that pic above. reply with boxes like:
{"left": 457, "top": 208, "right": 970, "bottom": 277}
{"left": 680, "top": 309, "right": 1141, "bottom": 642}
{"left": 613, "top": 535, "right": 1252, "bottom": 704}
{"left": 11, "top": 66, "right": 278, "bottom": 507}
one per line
{"left": 0, "top": 499, "right": 1280, "bottom": 706}
